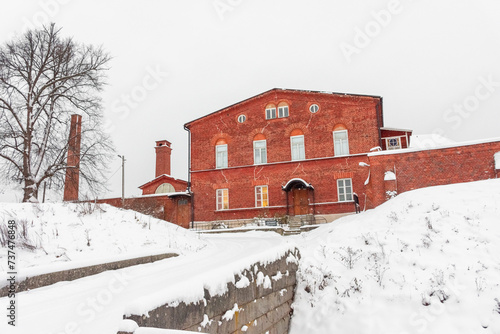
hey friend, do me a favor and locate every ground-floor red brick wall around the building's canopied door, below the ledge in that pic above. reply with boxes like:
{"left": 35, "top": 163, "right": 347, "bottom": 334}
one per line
{"left": 191, "top": 155, "right": 368, "bottom": 221}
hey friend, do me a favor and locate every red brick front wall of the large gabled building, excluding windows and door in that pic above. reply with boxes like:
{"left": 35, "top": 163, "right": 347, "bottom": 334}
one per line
{"left": 186, "top": 90, "right": 383, "bottom": 221}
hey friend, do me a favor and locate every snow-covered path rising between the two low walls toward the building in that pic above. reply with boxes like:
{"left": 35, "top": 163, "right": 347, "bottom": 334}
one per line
{"left": 0, "top": 232, "right": 291, "bottom": 334}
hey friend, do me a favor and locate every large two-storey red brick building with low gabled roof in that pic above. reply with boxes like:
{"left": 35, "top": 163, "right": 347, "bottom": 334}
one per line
{"left": 185, "top": 89, "right": 411, "bottom": 221}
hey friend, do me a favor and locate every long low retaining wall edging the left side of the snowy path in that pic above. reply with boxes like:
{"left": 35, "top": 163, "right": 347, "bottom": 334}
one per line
{"left": 0, "top": 253, "right": 178, "bottom": 297}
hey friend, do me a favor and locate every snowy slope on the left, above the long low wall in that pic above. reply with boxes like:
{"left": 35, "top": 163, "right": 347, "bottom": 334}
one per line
{"left": 0, "top": 203, "right": 206, "bottom": 278}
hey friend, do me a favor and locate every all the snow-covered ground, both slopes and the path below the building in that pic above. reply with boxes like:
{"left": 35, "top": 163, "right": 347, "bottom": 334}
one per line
{"left": 0, "top": 180, "right": 500, "bottom": 334}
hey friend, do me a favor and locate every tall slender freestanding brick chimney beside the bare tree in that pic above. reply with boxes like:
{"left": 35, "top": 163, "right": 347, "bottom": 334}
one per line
{"left": 63, "top": 114, "right": 82, "bottom": 201}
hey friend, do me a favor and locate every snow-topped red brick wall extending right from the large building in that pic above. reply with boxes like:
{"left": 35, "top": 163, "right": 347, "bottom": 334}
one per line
{"left": 368, "top": 141, "right": 500, "bottom": 207}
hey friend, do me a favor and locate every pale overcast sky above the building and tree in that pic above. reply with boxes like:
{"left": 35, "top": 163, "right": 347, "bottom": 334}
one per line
{"left": 0, "top": 0, "right": 500, "bottom": 197}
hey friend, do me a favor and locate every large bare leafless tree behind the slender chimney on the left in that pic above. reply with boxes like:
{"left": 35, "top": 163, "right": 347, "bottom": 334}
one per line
{"left": 0, "top": 24, "right": 113, "bottom": 202}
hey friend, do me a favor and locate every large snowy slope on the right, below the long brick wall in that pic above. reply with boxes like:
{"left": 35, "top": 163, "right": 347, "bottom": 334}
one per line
{"left": 290, "top": 180, "right": 500, "bottom": 334}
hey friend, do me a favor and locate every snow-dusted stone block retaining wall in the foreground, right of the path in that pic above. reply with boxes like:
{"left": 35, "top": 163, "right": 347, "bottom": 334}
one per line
{"left": 119, "top": 249, "right": 300, "bottom": 334}
